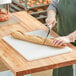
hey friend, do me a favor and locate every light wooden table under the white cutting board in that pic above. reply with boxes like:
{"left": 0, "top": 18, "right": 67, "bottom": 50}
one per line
{"left": 0, "top": 11, "right": 76, "bottom": 76}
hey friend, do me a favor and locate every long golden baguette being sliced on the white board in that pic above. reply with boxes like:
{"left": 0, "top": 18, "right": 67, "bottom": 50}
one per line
{"left": 11, "top": 31, "right": 65, "bottom": 48}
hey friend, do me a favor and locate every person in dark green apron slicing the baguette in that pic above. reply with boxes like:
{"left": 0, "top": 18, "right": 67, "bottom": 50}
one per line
{"left": 46, "top": 0, "right": 76, "bottom": 76}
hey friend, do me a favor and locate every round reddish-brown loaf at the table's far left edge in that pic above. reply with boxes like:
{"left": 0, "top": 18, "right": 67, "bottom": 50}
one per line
{"left": 0, "top": 8, "right": 10, "bottom": 22}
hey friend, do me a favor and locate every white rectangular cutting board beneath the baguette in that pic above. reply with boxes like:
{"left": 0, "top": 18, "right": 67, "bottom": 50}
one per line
{"left": 3, "top": 30, "right": 72, "bottom": 61}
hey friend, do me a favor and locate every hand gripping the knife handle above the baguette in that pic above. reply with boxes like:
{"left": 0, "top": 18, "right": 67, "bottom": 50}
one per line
{"left": 46, "top": 14, "right": 56, "bottom": 27}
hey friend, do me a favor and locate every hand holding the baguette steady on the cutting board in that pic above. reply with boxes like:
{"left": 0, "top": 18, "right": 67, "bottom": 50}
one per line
{"left": 53, "top": 36, "right": 70, "bottom": 46}
